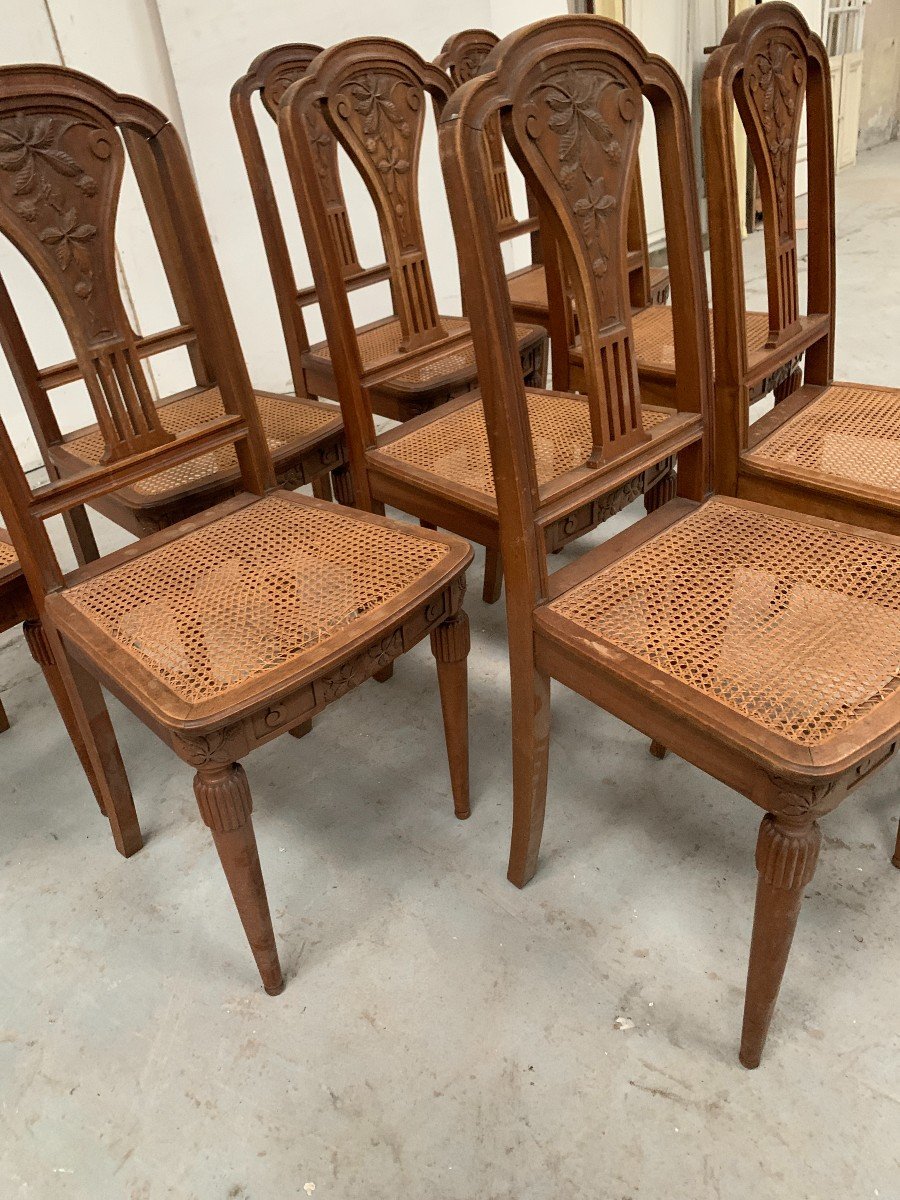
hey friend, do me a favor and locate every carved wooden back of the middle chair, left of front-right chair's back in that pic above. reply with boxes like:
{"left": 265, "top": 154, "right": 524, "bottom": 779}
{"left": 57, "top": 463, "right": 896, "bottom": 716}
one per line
{"left": 278, "top": 37, "right": 465, "bottom": 505}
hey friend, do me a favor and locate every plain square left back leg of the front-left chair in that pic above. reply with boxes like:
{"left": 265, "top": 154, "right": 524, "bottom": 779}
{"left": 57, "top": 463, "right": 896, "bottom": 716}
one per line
{"left": 23, "top": 620, "right": 144, "bottom": 858}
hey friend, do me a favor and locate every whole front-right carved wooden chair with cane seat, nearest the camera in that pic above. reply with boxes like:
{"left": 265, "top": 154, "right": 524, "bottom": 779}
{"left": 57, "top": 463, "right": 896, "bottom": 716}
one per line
{"left": 440, "top": 17, "right": 900, "bottom": 1067}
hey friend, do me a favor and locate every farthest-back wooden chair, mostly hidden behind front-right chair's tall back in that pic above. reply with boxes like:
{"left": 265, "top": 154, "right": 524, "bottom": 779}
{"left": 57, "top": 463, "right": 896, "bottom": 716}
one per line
{"left": 434, "top": 29, "right": 668, "bottom": 352}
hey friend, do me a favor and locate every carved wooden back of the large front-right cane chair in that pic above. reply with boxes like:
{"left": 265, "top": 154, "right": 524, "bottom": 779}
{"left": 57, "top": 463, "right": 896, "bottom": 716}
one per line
{"left": 440, "top": 17, "right": 712, "bottom": 614}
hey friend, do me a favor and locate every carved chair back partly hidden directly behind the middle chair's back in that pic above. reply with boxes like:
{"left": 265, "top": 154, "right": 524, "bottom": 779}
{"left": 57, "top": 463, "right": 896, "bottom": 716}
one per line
{"left": 232, "top": 42, "right": 398, "bottom": 396}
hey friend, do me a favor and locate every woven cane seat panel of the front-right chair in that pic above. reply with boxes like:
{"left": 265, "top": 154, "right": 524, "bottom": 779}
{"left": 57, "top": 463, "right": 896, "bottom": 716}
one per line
{"left": 550, "top": 500, "right": 900, "bottom": 745}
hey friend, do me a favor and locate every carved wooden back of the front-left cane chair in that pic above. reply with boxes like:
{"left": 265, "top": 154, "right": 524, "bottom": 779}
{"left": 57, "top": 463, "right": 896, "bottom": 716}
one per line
{"left": 0, "top": 66, "right": 274, "bottom": 610}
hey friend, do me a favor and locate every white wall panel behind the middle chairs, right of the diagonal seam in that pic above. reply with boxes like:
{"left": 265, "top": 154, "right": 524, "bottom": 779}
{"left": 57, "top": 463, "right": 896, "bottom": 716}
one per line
{"left": 152, "top": 0, "right": 565, "bottom": 390}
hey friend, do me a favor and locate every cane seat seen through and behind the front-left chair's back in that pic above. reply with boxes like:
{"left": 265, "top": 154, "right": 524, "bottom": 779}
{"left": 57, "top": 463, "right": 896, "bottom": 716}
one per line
{"left": 66, "top": 388, "right": 340, "bottom": 496}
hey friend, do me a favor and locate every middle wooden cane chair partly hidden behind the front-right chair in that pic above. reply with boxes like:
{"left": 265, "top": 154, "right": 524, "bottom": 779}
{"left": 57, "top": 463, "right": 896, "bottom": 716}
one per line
{"left": 278, "top": 38, "right": 692, "bottom": 602}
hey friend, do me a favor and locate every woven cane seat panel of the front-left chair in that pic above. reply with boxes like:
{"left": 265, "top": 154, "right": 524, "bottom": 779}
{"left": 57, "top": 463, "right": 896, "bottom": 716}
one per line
{"left": 66, "top": 493, "right": 448, "bottom": 704}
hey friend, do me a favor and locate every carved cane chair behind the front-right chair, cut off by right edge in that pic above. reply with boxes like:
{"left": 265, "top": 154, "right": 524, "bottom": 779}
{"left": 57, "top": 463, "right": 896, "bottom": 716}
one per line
{"left": 703, "top": 2, "right": 900, "bottom": 533}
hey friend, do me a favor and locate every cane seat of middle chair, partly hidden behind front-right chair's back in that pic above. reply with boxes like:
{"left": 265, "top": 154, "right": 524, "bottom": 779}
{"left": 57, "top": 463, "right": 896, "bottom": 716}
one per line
{"left": 380, "top": 391, "right": 674, "bottom": 496}
